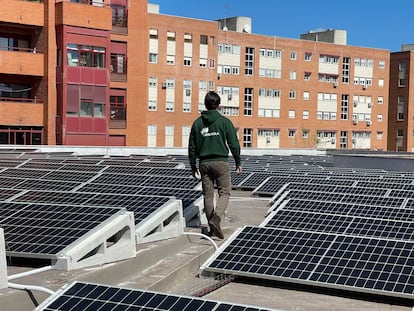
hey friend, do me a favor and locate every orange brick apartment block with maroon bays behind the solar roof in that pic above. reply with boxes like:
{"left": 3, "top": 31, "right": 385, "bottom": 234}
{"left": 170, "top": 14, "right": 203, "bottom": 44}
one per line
{"left": 0, "top": 0, "right": 414, "bottom": 151}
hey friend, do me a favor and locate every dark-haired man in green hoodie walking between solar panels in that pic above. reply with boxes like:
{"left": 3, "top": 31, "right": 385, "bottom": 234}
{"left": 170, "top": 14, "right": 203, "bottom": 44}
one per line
{"left": 188, "top": 91, "right": 242, "bottom": 239}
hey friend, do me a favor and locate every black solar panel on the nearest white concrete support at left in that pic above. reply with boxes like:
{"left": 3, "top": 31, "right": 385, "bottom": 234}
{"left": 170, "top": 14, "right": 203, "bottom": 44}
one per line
{"left": 0, "top": 202, "right": 120, "bottom": 258}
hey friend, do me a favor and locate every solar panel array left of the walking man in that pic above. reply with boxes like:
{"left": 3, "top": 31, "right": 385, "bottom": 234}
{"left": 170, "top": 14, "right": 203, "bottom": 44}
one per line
{"left": 0, "top": 151, "right": 202, "bottom": 268}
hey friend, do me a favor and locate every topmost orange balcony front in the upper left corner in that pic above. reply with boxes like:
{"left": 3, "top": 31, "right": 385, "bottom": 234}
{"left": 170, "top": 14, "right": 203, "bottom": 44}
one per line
{"left": 0, "top": 0, "right": 45, "bottom": 27}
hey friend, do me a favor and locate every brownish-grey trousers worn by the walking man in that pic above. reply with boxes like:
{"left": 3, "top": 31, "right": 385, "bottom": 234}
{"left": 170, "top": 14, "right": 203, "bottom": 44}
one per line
{"left": 200, "top": 161, "right": 231, "bottom": 220}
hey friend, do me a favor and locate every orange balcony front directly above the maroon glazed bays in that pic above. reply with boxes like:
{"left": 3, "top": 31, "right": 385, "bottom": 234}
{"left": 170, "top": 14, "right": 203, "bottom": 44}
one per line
{"left": 56, "top": 0, "right": 112, "bottom": 30}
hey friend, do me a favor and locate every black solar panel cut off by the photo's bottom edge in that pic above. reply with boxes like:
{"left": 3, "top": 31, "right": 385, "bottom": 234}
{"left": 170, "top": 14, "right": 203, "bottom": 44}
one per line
{"left": 35, "top": 282, "right": 270, "bottom": 311}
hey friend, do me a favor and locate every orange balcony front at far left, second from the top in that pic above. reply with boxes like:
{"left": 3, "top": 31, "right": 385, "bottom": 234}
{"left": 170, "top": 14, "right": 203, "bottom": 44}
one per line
{"left": 0, "top": 49, "right": 44, "bottom": 77}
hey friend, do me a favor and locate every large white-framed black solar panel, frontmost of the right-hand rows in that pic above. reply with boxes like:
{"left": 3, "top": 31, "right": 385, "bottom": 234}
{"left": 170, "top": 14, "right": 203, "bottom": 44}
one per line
{"left": 205, "top": 226, "right": 414, "bottom": 299}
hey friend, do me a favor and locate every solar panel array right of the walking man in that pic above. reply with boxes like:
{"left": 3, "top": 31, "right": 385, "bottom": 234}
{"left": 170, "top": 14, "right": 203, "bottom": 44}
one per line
{"left": 201, "top": 156, "right": 414, "bottom": 300}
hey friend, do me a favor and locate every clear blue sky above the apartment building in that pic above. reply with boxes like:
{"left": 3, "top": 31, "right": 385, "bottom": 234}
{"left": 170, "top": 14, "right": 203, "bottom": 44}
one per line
{"left": 152, "top": 0, "right": 414, "bottom": 52}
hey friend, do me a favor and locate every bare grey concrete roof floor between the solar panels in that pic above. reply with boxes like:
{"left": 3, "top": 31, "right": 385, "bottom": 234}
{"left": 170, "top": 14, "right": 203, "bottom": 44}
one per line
{"left": 0, "top": 190, "right": 412, "bottom": 311}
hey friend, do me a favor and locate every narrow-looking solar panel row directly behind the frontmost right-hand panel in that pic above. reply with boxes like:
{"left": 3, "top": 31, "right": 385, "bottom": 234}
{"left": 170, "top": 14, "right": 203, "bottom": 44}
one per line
{"left": 265, "top": 210, "right": 414, "bottom": 241}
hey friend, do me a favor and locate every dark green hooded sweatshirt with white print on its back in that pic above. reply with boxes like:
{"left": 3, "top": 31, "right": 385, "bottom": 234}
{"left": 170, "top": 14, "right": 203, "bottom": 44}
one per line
{"left": 188, "top": 110, "right": 241, "bottom": 170}
